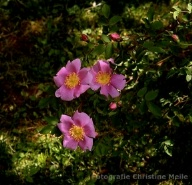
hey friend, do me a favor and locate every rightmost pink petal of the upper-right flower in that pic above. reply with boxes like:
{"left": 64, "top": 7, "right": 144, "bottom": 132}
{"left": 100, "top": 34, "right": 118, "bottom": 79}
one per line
{"left": 111, "top": 74, "right": 126, "bottom": 90}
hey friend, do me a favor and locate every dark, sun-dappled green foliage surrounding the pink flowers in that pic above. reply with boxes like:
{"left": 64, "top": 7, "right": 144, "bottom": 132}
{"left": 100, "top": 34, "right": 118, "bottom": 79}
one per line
{"left": 0, "top": 0, "right": 192, "bottom": 184}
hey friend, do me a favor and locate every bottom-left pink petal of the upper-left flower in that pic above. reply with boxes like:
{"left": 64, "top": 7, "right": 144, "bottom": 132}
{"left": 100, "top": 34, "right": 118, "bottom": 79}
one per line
{"left": 55, "top": 85, "right": 75, "bottom": 101}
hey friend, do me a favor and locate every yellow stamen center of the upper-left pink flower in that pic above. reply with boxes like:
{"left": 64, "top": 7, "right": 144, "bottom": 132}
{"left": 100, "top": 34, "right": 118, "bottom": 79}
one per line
{"left": 64, "top": 72, "right": 80, "bottom": 89}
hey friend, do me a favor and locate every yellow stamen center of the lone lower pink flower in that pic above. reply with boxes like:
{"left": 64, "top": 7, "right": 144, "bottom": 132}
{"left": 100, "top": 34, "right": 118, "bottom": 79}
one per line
{"left": 69, "top": 125, "right": 84, "bottom": 141}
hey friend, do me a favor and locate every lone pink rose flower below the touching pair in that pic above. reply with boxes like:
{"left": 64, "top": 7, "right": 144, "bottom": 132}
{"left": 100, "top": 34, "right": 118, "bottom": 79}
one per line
{"left": 58, "top": 111, "right": 96, "bottom": 151}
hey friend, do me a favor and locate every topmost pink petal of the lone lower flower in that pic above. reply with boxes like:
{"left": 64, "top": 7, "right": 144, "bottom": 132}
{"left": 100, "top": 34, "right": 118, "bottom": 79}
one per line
{"left": 72, "top": 111, "right": 91, "bottom": 127}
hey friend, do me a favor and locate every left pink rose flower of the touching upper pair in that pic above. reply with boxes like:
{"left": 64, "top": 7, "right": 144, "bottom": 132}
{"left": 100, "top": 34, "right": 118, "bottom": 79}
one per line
{"left": 53, "top": 59, "right": 91, "bottom": 101}
